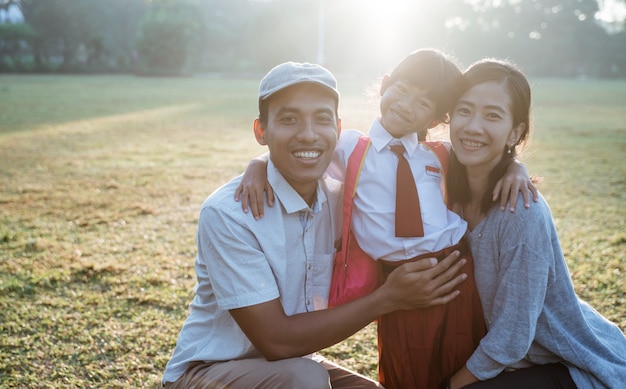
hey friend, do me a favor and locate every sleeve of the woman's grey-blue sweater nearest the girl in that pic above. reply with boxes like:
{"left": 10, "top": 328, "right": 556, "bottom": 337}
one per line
{"left": 467, "top": 204, "right": 555, "bottom": 380}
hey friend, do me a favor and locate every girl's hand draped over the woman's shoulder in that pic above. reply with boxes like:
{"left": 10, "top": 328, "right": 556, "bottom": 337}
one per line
{"left": 493, "top": 161, "right": 538, "bottom": 212}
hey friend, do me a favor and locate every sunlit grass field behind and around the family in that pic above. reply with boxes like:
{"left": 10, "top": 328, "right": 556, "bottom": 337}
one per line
{"left": 0, "top": 76, "right": 626, "bottom": 387}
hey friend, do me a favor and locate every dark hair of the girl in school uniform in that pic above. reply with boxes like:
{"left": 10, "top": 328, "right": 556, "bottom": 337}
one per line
{"left": 382, "top": 49, "right": 464, "bottom": 123}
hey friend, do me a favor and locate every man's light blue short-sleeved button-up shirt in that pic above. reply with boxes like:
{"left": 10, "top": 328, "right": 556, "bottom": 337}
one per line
{"left": 163, "top": 161, "right": 341, "bottom": 382}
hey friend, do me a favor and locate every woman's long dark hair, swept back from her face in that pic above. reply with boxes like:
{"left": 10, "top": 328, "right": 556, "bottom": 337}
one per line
{"left": 446, "top": 59, "right": 531, "bottom": 213}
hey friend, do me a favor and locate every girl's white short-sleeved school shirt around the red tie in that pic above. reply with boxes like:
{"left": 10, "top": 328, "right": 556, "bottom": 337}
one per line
{"left": 328, "top": 119, "right": 467, "bottom": 261}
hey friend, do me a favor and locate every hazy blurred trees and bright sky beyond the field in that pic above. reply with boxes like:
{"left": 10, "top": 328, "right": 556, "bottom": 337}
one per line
{"left": 0, "top": 0, "right": 626, "bottom": 78}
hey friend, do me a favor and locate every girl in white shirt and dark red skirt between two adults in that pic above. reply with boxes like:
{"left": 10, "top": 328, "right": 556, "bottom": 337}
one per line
{"left": 236, "top": 49, "right": 529, "bottom": 388}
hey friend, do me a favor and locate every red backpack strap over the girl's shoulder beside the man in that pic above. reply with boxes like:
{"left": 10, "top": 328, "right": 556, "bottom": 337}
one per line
{"left": 341, "top": 135, "right": 371, "bottom": 258}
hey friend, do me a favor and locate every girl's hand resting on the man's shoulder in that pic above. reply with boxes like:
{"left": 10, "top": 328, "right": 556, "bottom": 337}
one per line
{"left": 235, "top": 153, "right": 274, "bottom": 219}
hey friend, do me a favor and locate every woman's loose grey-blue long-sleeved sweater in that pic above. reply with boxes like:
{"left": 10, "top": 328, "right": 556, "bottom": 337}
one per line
{"left": 467, "top": 194, "right": 626, "bottom": 388}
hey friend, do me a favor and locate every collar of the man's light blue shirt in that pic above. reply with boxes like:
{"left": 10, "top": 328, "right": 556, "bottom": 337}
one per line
{"left": 267, "top": 158, "right": 326, "bottom": 213}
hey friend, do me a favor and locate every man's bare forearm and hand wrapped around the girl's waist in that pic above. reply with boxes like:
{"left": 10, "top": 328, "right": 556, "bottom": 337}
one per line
{"left": 230, "top": 252, "right": 467, "bottom": 360}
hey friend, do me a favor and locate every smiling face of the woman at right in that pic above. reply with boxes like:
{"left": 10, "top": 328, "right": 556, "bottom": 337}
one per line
{"left": 450, "top": 81, "right": 524, "bottom": 174}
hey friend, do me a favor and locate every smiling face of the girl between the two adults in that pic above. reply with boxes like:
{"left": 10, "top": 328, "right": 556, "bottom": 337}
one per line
{"left": 380, "top": 80, "right": 437, "bottom": 138}
